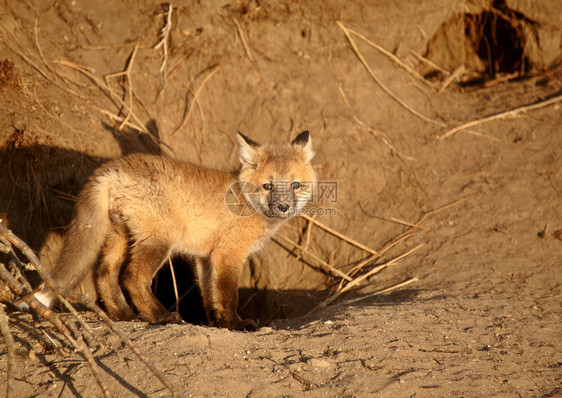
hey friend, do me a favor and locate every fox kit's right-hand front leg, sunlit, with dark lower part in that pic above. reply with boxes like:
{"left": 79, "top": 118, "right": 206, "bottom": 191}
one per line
{"left": 206, "top": 251, "right": 257, "bottom": 330}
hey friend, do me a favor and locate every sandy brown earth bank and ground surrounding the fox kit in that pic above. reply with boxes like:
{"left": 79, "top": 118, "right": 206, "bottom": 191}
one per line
{"left": 0, "top": 0, "right": 562, "bottom": 397}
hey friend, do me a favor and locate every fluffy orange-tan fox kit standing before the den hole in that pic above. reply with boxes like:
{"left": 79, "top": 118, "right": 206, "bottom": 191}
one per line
{"left": 37, "top": 131, "right": 315, "bottom": 329}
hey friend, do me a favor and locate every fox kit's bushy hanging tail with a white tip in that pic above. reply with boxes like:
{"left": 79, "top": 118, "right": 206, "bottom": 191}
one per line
{"left": 36, "top": 180, "right": 111, "bottom": 306}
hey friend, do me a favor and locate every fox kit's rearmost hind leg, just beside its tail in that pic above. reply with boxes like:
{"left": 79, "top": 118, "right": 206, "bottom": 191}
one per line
{"left": 96, "top": 226, "right": 135, "bottom": 321}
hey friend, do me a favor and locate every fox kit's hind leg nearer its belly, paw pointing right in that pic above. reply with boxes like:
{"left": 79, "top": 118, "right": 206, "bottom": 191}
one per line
{"left": 123, "top": 238, "right": 182, "bottom": 323}
